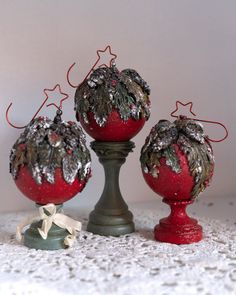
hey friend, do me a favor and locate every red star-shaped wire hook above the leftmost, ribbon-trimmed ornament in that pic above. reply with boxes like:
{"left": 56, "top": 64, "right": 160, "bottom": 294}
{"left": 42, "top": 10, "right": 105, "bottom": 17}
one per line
{"left": 6, "top": 84, "right": 69, "bottom": 129}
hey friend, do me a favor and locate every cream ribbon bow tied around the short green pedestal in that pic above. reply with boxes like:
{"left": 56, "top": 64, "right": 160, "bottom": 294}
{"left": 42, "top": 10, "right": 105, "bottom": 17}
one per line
{"left": 16, "top": 203, "right": 81, "bottom": 247}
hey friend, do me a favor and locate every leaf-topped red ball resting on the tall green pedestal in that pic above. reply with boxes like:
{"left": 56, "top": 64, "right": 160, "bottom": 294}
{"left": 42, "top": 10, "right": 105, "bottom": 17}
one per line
{"left": 75, "top": 65, "right": 150, "bottom": 142}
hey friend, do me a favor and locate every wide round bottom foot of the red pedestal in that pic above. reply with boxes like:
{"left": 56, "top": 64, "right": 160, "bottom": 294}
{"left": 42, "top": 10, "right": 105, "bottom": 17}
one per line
{"left": 154, "top": 218, "right": 203, "bottom": 245}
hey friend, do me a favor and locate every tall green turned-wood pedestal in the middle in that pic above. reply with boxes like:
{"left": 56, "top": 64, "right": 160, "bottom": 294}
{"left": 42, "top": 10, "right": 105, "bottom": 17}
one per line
{"left": 87, "top": 141, "right": 135, "bottom": 236}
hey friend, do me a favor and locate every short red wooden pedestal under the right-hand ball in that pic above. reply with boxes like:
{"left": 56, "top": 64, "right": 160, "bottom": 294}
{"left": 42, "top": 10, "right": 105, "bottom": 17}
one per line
{"left": 154, "top": 199, "right": 202, "bottom": 244}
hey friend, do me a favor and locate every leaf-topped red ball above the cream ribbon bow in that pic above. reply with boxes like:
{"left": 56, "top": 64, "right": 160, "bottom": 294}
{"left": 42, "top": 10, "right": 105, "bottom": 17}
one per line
{"left": 10, "top": 113, "right": 91, "bottom": 205}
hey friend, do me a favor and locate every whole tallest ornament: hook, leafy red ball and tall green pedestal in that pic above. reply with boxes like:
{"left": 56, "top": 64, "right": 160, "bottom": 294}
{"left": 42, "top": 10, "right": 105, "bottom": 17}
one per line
{"left": 67, "top": 46, "right": 150, "bottom": 236}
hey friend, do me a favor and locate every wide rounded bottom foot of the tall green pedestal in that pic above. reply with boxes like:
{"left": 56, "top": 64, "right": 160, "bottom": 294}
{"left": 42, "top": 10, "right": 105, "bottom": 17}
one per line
{"left": 87, "top": 210, "right": 134, "bottom": 236}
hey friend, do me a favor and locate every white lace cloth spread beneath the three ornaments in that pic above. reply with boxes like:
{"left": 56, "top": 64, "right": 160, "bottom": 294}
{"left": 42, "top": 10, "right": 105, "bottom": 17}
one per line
{"left": 0, "top": 209, "right": 236, "bottom": 295}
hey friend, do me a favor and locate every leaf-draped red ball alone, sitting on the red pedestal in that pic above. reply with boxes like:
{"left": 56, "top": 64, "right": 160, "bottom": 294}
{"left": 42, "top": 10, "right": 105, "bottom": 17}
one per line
{"left": 141, "top": 118, "right": 214, "bottom": 200}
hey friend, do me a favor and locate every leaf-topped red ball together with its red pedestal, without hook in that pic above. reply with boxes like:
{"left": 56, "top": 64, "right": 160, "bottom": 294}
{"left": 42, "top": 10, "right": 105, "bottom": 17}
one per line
{"left": 140, "top": 118, "right": 214, "bottom": 244}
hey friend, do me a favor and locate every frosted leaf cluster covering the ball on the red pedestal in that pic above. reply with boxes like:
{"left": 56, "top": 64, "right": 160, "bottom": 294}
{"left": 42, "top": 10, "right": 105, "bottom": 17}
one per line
{"left": 140, "top": 117, "right": 214, "bottom": 198}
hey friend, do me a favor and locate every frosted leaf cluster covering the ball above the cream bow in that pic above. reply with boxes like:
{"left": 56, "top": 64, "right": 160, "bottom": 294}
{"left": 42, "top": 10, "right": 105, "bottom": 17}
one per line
{"left": 10, "top": 112, "right": 91, "bottom": 185}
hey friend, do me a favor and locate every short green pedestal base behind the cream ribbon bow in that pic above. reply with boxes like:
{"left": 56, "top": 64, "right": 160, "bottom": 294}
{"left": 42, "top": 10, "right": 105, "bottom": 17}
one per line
{"left": 24, "top": 205, "right": 69, "bottom": 250}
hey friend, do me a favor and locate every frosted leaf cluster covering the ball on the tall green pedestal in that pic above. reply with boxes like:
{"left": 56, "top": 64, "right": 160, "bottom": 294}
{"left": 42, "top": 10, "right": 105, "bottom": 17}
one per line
{"left": 75, "top": 65, "right": 150, "bottom": 127}
